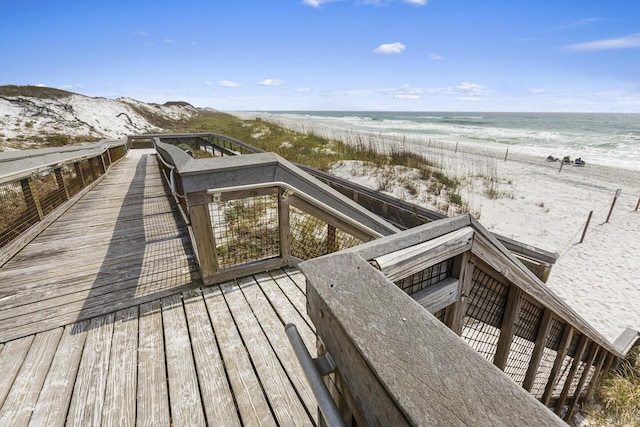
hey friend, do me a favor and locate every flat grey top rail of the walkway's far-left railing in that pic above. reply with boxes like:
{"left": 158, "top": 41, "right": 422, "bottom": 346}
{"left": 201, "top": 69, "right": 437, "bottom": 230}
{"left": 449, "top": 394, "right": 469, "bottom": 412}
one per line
{"left": 0, "top": 140, "right": 126, "bottom": 183}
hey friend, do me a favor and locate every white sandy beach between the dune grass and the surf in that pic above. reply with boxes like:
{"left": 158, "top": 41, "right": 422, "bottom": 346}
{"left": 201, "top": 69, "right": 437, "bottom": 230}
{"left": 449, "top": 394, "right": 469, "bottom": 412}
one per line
{"left": 333, "top": 137, "right": 640, "bottom": 341}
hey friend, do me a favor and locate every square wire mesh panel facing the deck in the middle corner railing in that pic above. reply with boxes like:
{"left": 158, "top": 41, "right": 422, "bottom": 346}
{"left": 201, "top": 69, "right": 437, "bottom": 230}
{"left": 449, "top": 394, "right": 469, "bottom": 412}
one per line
{"left": 209, "top": 195, "right": 280, "bottom": 268}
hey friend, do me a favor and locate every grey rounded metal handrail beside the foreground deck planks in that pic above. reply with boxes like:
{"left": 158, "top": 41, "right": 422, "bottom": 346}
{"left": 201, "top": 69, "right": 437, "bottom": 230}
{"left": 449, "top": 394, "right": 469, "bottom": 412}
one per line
{"left": 284, "top": 323, "right": 345, "bottom": 427}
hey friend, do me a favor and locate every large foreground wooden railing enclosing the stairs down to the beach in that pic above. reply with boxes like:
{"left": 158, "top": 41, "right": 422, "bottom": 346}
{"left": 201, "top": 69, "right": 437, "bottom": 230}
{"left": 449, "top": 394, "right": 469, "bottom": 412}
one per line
{"left": 299, "top": 215, "right": 639, "bottom": 425}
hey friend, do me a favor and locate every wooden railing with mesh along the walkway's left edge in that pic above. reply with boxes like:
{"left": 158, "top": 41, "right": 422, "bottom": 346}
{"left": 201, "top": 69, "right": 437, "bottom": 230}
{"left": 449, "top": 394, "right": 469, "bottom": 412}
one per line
{"left": 0, "top": 141, "right": 127, "bottom": 265}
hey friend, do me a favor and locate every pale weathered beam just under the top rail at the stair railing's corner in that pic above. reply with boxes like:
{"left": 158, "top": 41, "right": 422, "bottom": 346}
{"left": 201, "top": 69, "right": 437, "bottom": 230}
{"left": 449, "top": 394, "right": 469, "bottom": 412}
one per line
{"left": 374, "top": 227, "right": 474, "bottom": 282}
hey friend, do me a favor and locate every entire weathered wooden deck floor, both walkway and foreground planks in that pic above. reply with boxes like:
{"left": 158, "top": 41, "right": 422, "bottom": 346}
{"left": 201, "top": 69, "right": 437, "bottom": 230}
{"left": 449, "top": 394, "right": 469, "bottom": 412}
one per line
{"left": 0, "top": 150, "right": 317, "bottom": 426}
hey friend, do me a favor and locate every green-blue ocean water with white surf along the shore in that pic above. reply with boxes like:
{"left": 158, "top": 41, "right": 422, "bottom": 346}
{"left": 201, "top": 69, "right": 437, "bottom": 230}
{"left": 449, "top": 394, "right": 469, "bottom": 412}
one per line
{"left": 261, "top": 111, "right": 640, "bottom": 170}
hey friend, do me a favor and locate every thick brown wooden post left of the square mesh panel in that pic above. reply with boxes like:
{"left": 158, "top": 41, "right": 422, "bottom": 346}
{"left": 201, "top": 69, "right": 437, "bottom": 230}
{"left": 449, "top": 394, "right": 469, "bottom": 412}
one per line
{"left": 189, "top": 199, "right": 220, "bottom": 280}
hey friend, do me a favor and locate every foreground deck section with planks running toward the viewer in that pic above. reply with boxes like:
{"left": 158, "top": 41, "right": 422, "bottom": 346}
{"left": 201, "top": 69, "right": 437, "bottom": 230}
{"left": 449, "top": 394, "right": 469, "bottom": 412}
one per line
{"left": 0, "top": 270, "right": 318, "bottom": 426}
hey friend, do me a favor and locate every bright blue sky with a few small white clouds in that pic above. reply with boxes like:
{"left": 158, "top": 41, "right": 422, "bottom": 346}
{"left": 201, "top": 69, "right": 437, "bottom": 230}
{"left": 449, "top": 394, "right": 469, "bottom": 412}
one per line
{"left": 0, "top": 0, "right": 640, "bottom": 112}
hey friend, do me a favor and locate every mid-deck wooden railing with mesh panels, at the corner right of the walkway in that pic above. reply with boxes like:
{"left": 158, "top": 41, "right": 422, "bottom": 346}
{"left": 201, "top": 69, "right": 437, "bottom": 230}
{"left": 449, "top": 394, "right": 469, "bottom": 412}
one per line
{"left": 154, "top": 137, "right": 398, "bottom": 284}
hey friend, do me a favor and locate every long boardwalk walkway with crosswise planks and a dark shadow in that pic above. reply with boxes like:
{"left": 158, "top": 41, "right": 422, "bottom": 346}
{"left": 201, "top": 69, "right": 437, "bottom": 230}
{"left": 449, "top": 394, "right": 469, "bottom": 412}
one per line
{"left": 0, "top": 150, "right": 199, "bottom": 342}
